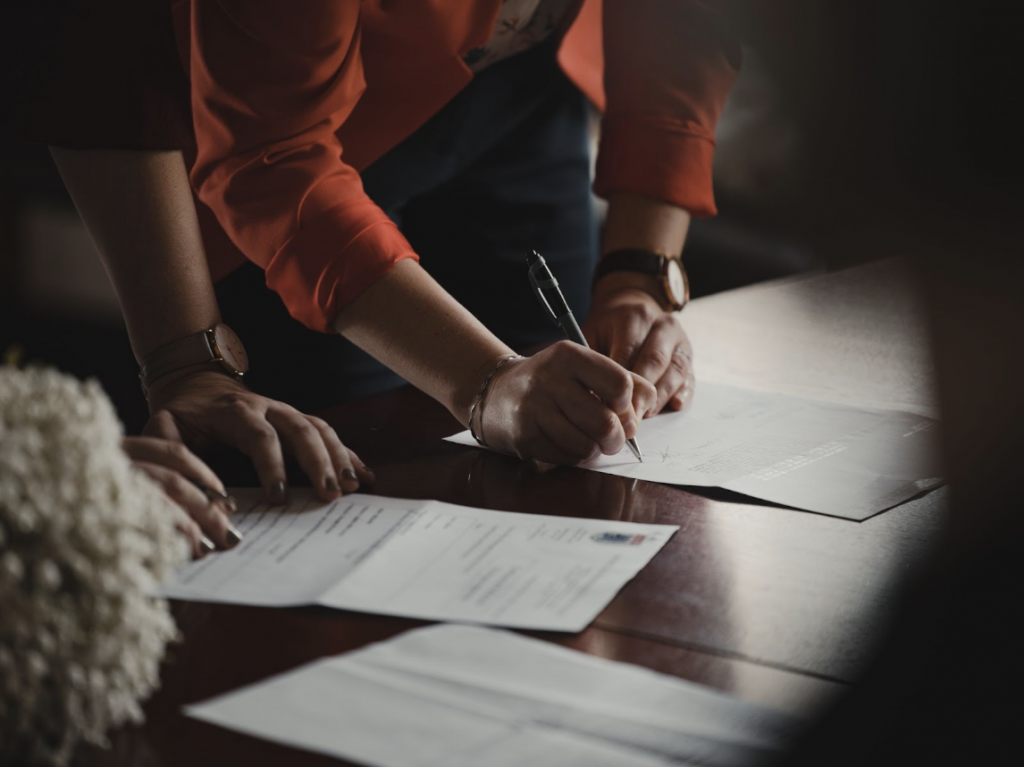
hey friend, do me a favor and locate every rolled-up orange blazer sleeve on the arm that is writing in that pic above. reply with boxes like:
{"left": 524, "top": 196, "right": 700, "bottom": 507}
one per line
{"left": 188, "top": 0, "right": 416, "bottom": 332}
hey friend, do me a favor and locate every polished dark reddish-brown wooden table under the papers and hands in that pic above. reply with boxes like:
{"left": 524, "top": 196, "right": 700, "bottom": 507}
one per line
{"left": 76, "top": 262, "right": 945, "bottom": 767}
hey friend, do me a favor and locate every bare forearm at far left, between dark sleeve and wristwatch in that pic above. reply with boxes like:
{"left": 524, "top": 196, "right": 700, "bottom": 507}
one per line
{"left": 50, "top": 147, "right": 220, "bottom": 363}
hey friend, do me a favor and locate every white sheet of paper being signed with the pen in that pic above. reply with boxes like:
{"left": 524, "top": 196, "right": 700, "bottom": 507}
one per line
{"left": 449, "top": 382, "right": 943, "bottom": 519}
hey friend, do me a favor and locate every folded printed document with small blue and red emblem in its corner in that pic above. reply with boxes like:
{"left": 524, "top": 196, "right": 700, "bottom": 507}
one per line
{"left": 163, "top": 489, "right": 679, "bottom": 631}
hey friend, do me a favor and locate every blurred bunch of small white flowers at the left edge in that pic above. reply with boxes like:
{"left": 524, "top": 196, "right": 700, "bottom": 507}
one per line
{"left": 0, "top": 367, "right": 186, "bottom": 765}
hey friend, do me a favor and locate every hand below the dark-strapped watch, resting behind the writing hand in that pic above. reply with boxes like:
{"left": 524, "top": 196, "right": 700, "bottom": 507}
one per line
{"left": 583, "top": 272, "right": 695, "bottom": 417}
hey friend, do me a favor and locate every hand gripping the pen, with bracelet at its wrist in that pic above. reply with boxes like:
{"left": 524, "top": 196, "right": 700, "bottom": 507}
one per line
{"left": 474, "top": 341, "right": 657, "bottom": 466}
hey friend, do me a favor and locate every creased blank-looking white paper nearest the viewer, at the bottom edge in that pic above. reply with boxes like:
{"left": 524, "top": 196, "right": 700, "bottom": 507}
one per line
{"left": 185, "top": 626, "right": 801, "bottom": 767}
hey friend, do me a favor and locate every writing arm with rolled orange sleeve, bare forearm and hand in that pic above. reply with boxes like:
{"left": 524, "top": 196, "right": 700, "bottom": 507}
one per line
{"left": 188, "top": 2, "right": 671, "bottom": 464}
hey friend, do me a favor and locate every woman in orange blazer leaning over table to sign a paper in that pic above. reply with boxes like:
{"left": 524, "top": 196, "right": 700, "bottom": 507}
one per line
{"left": 175, "top": 0, "right": 738, "bottom": 464}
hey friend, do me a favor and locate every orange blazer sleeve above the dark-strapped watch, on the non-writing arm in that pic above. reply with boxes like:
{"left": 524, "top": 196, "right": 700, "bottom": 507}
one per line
{"left": 594, "top": 0, "right": 740, "bottom": 217}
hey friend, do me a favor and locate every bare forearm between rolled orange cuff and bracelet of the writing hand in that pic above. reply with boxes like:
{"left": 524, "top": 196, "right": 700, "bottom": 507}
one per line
{"left": 335, "top": 259, "right": 513, "bottom": 425}
